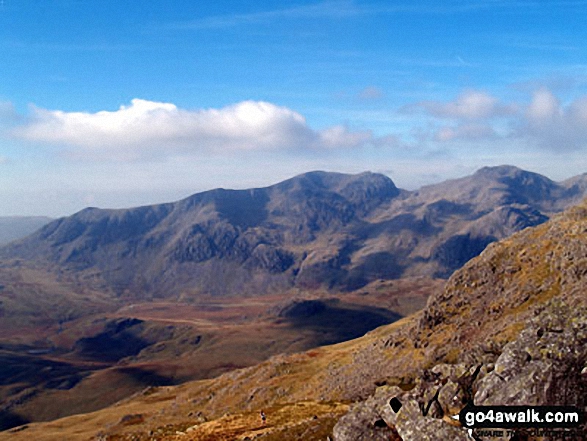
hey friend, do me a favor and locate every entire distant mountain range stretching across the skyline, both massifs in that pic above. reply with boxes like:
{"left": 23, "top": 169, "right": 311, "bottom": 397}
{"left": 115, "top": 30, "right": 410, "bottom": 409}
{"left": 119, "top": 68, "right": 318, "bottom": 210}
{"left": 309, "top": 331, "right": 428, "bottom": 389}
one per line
{"left": 0, "top": 166, "right": 587, "bottom": 298}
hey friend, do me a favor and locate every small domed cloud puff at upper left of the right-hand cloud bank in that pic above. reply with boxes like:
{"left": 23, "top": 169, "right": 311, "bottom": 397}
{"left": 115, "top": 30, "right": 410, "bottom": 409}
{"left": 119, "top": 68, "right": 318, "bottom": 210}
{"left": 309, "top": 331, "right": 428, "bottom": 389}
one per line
{"left": 405, "top": 90, "right": 516, "bottom": 120}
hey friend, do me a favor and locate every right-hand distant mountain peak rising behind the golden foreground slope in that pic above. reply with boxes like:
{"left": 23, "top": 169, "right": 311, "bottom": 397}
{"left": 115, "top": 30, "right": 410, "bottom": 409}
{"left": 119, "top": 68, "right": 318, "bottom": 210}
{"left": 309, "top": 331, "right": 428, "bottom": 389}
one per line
{"left": 378, "top": 166, "right": 587, "bottom": 277}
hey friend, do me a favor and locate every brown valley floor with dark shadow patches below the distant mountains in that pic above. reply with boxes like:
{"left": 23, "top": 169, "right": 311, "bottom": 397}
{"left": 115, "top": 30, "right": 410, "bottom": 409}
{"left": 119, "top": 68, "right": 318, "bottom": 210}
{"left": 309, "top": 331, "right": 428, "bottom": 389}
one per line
{"left": 0, "top": 254, "right": 444, "bottom": 429}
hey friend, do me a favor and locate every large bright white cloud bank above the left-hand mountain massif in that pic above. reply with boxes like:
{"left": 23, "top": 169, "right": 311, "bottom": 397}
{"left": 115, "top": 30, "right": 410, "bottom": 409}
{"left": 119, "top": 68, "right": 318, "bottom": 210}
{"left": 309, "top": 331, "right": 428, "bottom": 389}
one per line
{"left": 12, "top": 99, "right": 374, "bottom": 159}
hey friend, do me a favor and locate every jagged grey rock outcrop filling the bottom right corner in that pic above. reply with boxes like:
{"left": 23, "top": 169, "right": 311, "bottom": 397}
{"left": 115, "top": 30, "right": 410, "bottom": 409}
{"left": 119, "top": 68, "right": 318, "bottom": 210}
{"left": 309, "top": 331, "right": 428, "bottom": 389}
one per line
{"left": 334, "top": 301, "right": 587, "bottom": 441}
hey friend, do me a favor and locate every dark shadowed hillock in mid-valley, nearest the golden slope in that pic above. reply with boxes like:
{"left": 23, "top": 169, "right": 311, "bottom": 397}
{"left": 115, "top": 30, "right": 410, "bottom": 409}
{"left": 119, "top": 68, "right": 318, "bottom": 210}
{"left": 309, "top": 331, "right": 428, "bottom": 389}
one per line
{"left": 279, "top": 300, "right": 402, "bottom": 346}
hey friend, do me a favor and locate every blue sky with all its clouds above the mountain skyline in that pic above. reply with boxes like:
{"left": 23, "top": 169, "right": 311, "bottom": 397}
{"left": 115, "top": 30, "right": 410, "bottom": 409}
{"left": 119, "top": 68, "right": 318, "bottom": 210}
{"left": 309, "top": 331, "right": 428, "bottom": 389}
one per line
{"left": 0, "top": 0, "right": 587, "bottom": 217}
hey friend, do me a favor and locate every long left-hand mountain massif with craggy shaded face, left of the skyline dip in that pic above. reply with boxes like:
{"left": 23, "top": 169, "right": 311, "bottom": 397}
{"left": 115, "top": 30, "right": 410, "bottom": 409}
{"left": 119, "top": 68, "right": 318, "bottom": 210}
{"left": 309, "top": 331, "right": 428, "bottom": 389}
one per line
{"left": 3, "top": 172, "right": 399, "bottom": 296}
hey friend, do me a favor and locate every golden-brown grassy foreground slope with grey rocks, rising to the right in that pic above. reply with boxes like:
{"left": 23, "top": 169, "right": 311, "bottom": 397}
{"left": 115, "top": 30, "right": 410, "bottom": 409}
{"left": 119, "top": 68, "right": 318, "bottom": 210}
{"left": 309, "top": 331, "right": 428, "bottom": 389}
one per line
{"left": 0, "top": 198, "right": 587, "bottom": 441}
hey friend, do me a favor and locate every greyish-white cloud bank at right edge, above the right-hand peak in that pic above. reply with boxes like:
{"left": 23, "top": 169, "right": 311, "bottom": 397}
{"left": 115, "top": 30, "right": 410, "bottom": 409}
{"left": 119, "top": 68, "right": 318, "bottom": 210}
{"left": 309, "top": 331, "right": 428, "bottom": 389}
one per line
{"left": 401, "top": 86, "right": 587, "bottom": 153}
